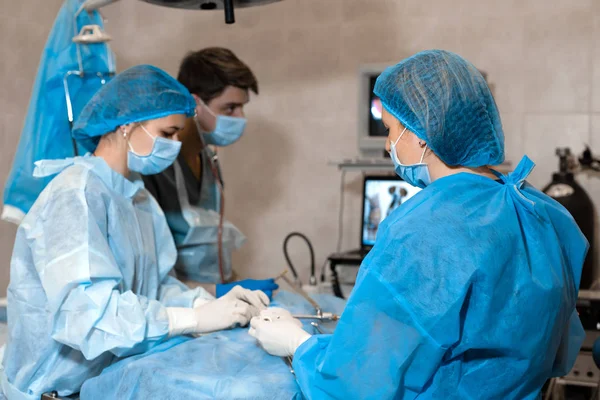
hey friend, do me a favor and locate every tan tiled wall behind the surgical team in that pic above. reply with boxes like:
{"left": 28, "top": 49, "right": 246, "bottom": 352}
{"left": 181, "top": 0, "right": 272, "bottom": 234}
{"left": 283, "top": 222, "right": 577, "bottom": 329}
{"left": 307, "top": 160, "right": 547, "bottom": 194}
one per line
{"left": 0, "top": 0, "right": 600, "bottom": 294}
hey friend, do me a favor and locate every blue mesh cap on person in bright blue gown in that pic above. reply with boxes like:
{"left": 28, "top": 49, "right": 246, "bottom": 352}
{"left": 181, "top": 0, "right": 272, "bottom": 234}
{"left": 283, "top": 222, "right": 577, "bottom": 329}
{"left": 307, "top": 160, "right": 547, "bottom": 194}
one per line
{"left": 374, "top": 50, "right": 504, "bottom": 167}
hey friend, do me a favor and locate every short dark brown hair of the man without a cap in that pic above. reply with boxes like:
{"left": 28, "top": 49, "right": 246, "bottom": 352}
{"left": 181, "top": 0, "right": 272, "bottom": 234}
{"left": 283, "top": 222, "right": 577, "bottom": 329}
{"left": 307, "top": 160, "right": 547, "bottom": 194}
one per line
{"left": 177, "top": 47, "right": 258, "bottom": 103}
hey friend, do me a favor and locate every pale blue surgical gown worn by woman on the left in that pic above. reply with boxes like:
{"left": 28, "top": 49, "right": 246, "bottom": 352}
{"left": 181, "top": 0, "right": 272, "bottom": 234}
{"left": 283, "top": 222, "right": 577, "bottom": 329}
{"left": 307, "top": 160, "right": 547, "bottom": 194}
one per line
{"left": 1, "top": 156, "right": 211, "bottom": 400}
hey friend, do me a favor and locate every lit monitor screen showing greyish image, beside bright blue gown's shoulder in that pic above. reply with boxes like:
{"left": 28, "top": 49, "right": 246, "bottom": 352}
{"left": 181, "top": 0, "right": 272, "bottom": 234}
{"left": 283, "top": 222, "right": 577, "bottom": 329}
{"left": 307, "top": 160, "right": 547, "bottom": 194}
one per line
{"left": 362, "top": 177, "right": 421, "bottom": 246}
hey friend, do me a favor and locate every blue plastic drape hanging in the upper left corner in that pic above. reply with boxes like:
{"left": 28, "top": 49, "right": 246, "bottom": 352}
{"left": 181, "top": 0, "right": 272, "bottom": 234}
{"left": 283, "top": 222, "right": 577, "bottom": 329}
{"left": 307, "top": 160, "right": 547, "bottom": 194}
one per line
{"left": 2, "top": 0, "right": 115, "bottom": 224}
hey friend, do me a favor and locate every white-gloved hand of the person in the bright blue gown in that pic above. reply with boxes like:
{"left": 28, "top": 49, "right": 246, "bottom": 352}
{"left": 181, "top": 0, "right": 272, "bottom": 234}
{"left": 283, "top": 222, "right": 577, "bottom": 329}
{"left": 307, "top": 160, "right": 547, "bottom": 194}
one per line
{"left": 248, "top": 311, "right": 311, "bottom": 357}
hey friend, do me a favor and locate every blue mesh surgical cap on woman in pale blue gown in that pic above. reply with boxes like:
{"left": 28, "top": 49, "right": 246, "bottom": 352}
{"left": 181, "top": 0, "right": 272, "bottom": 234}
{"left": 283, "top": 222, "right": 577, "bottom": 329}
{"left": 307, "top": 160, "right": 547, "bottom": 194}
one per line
{"left": 73, "top": 65, "right": 196, "bottom": 151}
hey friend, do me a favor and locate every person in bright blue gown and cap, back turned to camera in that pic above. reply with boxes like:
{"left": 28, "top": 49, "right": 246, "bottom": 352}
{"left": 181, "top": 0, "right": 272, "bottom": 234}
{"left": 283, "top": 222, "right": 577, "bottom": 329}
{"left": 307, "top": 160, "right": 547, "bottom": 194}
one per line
{"left": 250, "top": 50, "right": 588, "bottom": 399}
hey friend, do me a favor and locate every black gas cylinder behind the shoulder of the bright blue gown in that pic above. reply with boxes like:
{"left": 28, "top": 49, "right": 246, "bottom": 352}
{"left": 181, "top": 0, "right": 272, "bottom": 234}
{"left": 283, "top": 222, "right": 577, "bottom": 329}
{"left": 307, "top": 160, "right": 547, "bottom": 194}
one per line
{"left": 544, "top": 148, "right": 595, "bottom": 289}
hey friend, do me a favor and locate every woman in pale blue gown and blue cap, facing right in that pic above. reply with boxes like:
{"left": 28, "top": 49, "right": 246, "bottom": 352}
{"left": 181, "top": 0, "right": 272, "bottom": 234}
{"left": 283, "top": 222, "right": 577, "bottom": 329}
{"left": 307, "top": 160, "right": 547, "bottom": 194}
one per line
{"left": 0, "top": 65, "right": 269, "bottom": 400}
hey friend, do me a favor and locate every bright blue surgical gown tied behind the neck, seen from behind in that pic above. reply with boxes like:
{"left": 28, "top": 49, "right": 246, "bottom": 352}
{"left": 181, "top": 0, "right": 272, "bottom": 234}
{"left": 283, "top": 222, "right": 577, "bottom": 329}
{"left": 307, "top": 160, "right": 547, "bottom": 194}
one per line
{"left": 293, "top": 158, "right": 588, "bottom": 400}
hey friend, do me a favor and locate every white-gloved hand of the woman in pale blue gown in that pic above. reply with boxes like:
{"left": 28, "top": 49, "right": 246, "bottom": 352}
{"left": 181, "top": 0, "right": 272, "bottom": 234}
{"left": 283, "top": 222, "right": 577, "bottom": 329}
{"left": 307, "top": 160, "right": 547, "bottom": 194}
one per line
{"left": 167, "top": 286, "right": 270, "bottom": 336}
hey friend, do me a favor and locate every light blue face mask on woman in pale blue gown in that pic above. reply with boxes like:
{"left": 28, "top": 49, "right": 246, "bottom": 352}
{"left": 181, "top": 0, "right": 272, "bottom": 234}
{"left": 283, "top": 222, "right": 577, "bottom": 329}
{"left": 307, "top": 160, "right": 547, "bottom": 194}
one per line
{"left": 127, "top": 125, "right": 181, "bottom": 175}
